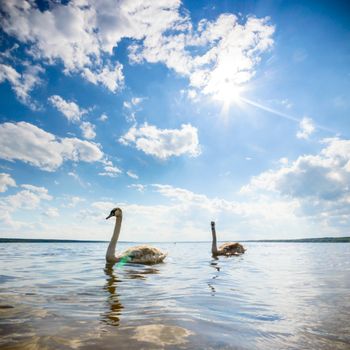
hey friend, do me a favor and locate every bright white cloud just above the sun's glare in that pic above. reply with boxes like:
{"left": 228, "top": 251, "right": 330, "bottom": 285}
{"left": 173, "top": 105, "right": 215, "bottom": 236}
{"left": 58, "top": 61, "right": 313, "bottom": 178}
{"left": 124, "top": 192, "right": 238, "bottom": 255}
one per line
{"left": 129, "top": 14, "right": 274, "bottom": 99}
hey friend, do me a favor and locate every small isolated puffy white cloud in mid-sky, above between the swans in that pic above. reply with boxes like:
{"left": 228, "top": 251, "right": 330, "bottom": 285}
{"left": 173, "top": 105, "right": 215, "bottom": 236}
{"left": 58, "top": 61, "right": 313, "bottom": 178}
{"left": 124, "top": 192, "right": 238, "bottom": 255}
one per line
{"left": 119, "top": 123, "right": 200, "bottom": 159}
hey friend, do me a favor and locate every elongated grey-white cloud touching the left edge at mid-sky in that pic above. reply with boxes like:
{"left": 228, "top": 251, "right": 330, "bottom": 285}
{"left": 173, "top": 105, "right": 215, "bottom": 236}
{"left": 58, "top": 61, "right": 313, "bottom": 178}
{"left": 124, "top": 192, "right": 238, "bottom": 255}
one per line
{"left": 0, "top": 122, "right": 103, "bottom": 171}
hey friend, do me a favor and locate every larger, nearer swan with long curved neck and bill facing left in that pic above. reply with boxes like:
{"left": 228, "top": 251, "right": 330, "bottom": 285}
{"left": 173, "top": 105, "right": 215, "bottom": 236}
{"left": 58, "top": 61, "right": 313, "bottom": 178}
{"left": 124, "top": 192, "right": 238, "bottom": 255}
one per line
{"left": 106, "top": 208, "right": 166, "bottom": 264}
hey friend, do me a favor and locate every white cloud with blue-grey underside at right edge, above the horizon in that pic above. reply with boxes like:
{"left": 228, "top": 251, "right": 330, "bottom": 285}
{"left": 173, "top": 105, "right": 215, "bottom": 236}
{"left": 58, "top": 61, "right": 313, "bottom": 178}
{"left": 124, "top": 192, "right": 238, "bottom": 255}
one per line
{"left": 242, "top": 138, "right": 350, "bottom": 199}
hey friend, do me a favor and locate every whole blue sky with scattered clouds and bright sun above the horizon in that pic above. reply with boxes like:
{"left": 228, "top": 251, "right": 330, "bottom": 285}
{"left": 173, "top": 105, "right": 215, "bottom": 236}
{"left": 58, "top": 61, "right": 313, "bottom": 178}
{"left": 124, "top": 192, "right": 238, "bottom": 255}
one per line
{"left": 0, "top": 0, "right": 350, "bottom": 241}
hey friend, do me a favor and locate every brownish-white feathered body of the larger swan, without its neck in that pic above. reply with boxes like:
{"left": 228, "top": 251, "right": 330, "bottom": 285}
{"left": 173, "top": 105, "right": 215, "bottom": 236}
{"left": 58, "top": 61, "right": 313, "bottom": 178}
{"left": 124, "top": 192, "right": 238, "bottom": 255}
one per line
{"left": 118, "top": 245, "right": 166, "bottom": 264}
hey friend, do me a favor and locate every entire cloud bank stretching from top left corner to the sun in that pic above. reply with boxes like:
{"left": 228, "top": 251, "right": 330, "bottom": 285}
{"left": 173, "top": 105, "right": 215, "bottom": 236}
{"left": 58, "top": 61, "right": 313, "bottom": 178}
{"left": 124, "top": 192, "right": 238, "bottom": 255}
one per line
{"left": 1, "top": 0, "right": 274, "bottom": 96}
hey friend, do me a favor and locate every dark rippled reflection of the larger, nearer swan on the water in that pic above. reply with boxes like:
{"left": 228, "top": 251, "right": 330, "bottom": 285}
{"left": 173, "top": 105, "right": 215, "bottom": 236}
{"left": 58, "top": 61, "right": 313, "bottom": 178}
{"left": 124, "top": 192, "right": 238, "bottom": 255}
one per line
{"left": 102, "top": 264, "right": 159, "bottom": 326}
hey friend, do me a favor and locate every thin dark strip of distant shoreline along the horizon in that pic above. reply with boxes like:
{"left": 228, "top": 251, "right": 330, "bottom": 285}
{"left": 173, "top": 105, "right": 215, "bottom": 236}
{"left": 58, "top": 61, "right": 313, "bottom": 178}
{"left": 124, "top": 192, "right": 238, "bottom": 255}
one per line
{"left": 0, "top": 237, "right": 350, "bottom": 244}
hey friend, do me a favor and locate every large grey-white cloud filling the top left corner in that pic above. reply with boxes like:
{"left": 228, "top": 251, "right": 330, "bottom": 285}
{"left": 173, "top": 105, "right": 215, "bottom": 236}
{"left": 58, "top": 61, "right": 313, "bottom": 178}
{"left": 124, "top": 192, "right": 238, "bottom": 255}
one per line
{"left": 1, "top": 0, "right": 180, "bottom": 92}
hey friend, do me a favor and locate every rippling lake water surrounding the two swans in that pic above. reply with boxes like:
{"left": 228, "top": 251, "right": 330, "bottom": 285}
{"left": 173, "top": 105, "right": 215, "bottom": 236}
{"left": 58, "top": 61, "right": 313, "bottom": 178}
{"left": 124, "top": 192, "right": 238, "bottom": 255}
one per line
{"left": 0, "top": 243, "right": 350, "bottom": 349}
